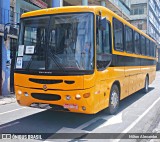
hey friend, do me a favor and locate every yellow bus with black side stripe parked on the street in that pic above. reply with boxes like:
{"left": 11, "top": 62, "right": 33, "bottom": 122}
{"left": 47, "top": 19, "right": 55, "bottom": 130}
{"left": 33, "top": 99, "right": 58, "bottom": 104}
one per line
{"left": 14, "top": 6, "right": 156, "bottom": 114}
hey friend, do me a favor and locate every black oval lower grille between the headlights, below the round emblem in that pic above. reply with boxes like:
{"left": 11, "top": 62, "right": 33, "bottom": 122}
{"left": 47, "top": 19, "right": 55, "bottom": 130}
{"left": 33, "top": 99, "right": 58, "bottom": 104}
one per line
{"left": 31, "top": 93, "right": 61, "bottom": 101}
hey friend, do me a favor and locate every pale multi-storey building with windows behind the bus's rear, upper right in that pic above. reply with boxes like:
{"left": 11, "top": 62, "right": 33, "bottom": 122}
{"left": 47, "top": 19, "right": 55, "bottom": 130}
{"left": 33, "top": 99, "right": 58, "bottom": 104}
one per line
{"left": 130, "top": 0, "right": 160, "bottom": 70}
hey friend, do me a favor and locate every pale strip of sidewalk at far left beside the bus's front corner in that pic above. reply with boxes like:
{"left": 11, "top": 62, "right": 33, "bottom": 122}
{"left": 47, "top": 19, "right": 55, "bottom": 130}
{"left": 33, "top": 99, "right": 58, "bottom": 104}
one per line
{"left": 0, "top": 94, "right": 16, "bottom": 105}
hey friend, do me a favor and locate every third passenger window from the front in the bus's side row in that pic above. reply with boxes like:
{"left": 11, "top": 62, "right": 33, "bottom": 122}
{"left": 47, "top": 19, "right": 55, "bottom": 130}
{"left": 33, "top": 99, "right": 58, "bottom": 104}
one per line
{"left": 134, "top": 32, "right": 141, "bottom": 54}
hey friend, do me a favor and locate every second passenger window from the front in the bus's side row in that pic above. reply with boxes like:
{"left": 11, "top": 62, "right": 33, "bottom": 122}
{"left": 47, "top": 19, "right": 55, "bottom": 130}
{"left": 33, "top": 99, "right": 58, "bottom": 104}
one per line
{"left": 125, "top": 26, "right": 133, "bottom": 53}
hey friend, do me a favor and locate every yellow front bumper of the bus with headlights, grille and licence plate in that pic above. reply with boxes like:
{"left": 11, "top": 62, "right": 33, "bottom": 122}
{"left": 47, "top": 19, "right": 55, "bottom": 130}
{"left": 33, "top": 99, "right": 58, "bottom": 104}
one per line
{"left": 15, "top": 86, "right": 97, "bottom": 114}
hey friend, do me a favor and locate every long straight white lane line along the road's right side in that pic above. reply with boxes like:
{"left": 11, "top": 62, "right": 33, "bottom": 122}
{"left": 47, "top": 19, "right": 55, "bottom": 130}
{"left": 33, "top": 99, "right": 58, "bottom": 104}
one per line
{"left": 116, "top": 97, "right": 160, "bottom": 142}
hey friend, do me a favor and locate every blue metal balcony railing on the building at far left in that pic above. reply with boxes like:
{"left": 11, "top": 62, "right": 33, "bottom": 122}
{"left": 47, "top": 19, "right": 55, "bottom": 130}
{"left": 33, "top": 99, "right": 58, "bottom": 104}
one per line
{"left": 0, "top": 8, "right": 20, "bottom": 25}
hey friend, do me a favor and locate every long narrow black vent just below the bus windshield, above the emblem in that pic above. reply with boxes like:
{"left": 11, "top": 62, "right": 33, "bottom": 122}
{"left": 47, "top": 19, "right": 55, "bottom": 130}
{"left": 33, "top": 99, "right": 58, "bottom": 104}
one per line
{"left": 29, "top": 78, "right": 63, "bottom": 84}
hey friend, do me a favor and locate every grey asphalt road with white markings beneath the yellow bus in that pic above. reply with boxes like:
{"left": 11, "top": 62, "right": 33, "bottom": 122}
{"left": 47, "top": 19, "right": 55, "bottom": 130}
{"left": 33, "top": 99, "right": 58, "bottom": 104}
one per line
{"left": 0, "top": 72, "right": 160, "bottom": 142}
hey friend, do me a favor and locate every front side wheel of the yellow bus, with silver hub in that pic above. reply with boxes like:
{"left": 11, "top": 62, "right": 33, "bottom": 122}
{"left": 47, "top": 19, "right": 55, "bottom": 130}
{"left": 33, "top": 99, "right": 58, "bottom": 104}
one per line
{"left": 108, "top": 84, "right": 120, "bottom": 115}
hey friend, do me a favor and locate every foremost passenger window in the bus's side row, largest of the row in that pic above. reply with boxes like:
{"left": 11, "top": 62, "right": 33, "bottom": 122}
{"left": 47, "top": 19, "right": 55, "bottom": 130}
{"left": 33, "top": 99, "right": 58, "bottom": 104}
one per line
{"left": 113, "top": 18, "right": 124, "bottom": 51}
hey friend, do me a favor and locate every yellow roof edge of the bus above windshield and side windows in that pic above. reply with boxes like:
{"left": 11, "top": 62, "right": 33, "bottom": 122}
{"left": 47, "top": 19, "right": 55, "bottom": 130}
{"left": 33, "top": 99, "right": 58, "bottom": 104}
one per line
{"left": 21, "top": 6, "right": 156, "bottom": 42}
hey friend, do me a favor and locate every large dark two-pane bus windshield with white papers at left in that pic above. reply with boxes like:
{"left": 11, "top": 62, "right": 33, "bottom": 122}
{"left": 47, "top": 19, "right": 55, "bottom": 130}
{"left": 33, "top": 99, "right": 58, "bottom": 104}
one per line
{"left": 15, "top": 13, "right": 94, "bottom": 73}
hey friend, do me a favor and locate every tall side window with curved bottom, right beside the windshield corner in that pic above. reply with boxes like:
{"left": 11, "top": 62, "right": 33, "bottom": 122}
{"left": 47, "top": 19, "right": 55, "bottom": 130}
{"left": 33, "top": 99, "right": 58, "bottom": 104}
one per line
{"left": 96, "top": 17, "right": 112, "bottom": 70}
